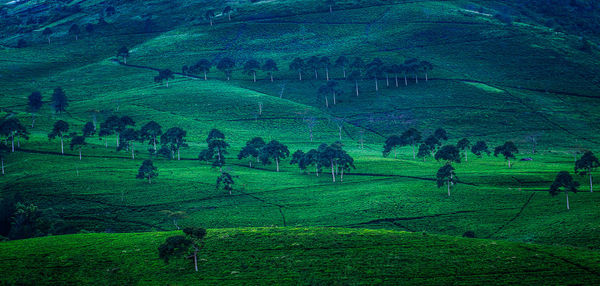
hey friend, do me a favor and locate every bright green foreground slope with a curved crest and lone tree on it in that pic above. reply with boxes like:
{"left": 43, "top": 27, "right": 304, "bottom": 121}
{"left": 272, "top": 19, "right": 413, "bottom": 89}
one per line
{"left": 0, "top": 228, "right": 600, "bottom": 285}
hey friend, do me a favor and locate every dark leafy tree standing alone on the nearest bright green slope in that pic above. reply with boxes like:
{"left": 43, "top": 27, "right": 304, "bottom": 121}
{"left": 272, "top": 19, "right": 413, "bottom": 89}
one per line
{"left": 158, "top": 227, "right": 206, "bottom": 272}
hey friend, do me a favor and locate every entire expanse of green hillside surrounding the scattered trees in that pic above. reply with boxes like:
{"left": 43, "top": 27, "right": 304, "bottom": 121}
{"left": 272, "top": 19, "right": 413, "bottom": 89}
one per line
{"left": 0, "top": 0, "right": 600, "bottom": 284}
